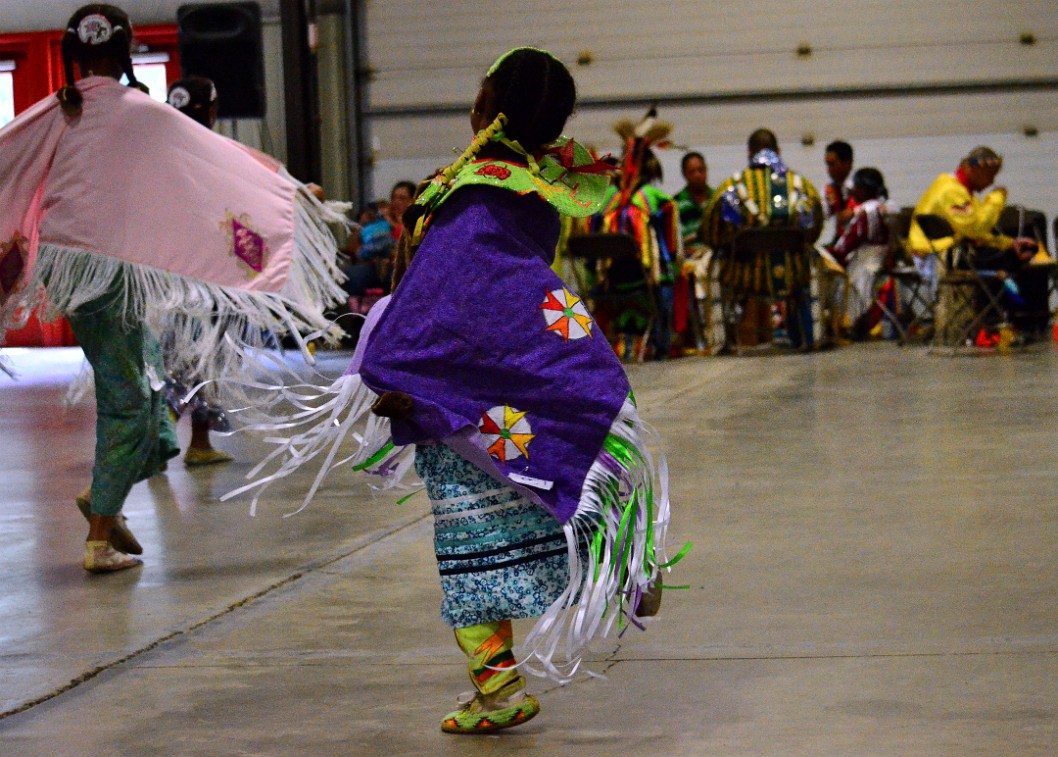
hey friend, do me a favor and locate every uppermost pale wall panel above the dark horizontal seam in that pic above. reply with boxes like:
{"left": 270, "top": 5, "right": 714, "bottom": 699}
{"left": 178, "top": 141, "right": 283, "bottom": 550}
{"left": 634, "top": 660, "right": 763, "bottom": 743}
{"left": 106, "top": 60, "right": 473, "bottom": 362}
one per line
{"left": 367, "top": 0, "right": 1058, "bottom": 108}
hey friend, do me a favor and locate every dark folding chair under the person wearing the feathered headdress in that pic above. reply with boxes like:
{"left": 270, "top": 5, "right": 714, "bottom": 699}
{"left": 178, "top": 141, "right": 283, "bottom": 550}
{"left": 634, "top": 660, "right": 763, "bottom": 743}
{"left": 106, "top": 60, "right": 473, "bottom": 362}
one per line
{"left": 567, "top": 234, "right": 659, "bottom": 363}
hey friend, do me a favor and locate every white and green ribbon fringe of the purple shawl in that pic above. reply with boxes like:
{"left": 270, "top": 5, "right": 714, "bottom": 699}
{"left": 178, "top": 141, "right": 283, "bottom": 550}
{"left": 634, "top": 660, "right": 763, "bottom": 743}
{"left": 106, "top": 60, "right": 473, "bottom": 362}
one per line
{"left": 229, "top": 374, "right": 670, "bottom": 684}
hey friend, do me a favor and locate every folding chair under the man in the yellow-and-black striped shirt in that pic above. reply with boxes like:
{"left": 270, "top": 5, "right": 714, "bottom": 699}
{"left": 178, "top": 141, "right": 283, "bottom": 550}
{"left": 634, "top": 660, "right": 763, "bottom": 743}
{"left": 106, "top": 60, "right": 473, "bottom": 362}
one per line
{"left": 718, "top": 227, "right": 814, "bottom": 353}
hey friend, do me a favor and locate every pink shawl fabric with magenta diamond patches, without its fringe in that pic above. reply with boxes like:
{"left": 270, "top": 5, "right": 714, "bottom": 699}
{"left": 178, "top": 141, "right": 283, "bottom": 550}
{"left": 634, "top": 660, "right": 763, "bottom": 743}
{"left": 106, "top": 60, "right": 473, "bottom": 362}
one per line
{"left": 0, "top": 76, "right": 296, "bottom": 310}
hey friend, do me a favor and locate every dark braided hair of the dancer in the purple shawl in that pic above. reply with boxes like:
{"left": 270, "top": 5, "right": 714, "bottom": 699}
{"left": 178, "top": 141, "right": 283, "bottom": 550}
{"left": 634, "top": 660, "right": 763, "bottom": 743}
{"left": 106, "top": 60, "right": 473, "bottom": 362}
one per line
{"left": 481, "top": 48, "right": 577, "bottom": 152}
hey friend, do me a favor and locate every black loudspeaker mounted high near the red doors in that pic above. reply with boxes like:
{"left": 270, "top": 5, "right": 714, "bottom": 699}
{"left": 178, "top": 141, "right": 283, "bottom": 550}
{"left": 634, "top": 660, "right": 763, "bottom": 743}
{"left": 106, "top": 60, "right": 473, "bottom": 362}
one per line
{"left": 177, "top": 2, "right": 265, "bottom": 118}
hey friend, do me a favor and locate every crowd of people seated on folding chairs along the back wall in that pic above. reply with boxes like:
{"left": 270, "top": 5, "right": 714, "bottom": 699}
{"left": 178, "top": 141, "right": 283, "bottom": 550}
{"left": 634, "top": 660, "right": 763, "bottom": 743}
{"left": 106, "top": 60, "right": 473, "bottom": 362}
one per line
{"left": 353, "top": 131, "right": 1054, "bottom": 361}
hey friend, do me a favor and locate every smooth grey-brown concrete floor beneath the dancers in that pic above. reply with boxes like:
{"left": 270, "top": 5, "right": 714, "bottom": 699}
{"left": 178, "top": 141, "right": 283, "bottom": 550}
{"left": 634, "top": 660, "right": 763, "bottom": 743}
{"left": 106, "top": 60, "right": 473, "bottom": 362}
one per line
{"left": 0, "top": 345, "right": 1058, "bottom": 757}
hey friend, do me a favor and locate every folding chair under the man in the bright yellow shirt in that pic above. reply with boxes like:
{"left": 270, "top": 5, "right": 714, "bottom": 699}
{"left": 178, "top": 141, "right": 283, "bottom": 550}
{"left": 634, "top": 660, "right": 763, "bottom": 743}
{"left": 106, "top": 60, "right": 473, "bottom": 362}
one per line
{"left": 915, "top": 214, "right": 1006, "bottom": 351}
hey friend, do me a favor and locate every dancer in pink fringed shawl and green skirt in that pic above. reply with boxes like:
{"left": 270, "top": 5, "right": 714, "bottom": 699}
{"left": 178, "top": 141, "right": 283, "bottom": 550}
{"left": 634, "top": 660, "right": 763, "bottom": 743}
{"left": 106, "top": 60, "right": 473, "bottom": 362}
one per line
{"left": 0, "top": 4, "right": 341, "bottom": 572}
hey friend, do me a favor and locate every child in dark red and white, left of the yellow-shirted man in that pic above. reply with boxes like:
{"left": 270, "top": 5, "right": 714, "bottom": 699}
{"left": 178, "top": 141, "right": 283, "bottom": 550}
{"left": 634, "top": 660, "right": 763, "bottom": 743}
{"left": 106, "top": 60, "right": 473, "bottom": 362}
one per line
{"left": 832, "top": 168, "right": 899, "bottom": 338}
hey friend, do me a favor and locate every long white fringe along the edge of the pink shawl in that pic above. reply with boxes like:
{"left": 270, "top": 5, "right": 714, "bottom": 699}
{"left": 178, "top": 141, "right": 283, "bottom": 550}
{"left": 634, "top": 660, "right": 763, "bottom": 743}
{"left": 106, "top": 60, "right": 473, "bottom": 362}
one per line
{"left": 0, "top": 192, "right": 346, "bottom": 406}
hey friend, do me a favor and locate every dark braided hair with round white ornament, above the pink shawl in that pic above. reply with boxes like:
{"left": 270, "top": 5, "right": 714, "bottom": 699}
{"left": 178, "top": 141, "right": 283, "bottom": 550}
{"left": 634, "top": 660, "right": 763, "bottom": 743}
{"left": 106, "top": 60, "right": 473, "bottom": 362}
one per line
{"left": 55, "top": 3, "right": 147, "bottom": 116}
